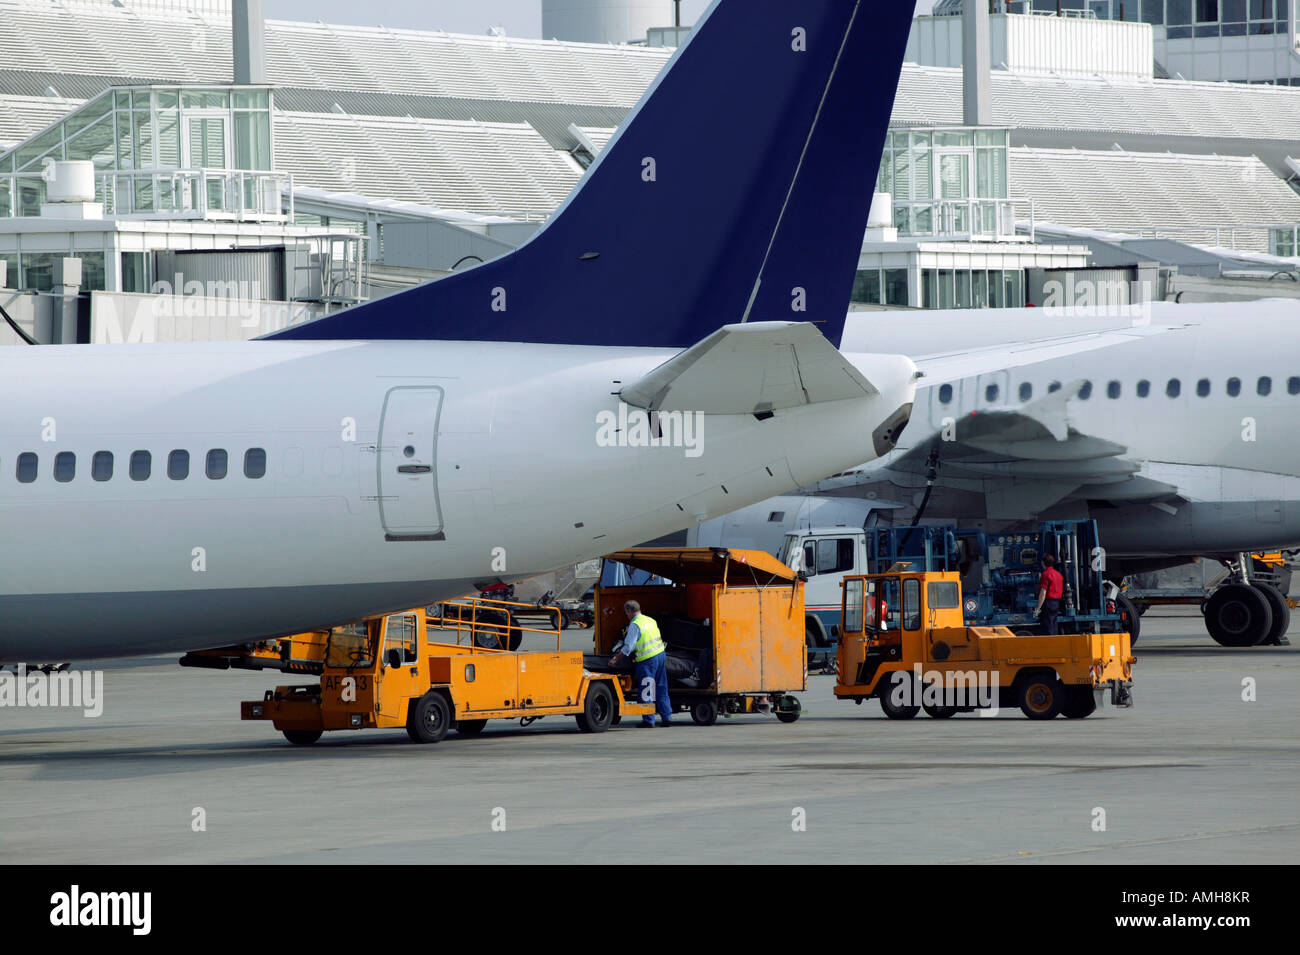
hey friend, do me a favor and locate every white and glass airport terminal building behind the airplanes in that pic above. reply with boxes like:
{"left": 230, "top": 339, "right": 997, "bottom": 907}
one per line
{"left": 0, "top": 0, "right": 1300, "bottom": 343}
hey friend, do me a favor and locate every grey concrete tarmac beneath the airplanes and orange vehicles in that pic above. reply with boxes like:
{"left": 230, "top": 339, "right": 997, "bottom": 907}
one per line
{"left": 0, "top": 609, "right": 1300, "bottom": 865}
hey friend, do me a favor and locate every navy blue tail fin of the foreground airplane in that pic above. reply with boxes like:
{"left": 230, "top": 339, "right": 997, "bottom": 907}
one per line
{"left": 267, "top": 0, "right": 913, "bottom": 348}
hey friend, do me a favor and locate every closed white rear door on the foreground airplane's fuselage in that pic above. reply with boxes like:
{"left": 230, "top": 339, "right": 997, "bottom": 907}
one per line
{"left": 376, "top": 386, "right": 446, "bottom": 541}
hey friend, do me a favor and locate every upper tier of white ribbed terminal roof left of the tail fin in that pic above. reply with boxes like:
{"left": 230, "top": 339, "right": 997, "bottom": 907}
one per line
{"left": 0, "top": 0, "right": 672, "bottom": 107}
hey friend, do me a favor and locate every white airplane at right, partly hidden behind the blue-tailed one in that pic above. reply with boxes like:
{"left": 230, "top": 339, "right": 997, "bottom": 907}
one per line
{"left": 722, "top": 300, "right": 1300, "bottom": 646}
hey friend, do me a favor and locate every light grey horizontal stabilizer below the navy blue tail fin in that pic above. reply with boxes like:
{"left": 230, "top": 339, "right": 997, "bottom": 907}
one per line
{"left": 619, "top": 322, "right": 878, "bottom": 414}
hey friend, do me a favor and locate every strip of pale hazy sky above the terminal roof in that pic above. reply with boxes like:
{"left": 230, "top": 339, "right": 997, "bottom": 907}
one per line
{"left": 264, "top": 0, "right": 933, "bottom": 36}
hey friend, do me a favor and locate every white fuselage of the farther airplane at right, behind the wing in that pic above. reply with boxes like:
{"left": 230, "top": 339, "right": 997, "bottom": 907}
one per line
{"left": 820, "top": 300, "right": 1300, "bottom": 556}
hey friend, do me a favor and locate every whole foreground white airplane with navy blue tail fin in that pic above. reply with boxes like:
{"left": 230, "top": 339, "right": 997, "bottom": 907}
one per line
{"left": 0, "top": 0, "right": 1154, "bottom": 661}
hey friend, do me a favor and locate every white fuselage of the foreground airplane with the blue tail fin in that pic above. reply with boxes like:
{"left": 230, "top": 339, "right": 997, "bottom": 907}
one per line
{"left": 0, "top": 342, "right": 915, "bottom": 660}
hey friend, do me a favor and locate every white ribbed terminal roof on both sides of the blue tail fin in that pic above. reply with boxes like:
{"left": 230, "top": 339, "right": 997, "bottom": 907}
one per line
{"left": 0, "top": 0, "right": 1300, "bottom": 240}
